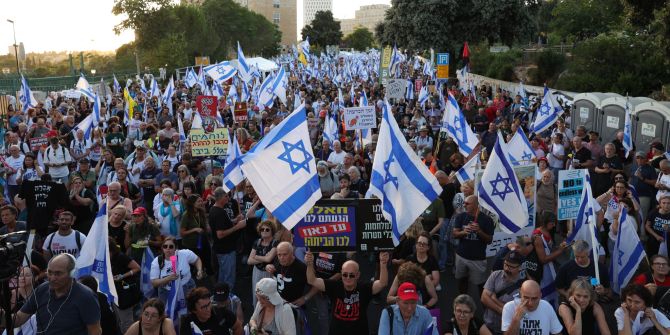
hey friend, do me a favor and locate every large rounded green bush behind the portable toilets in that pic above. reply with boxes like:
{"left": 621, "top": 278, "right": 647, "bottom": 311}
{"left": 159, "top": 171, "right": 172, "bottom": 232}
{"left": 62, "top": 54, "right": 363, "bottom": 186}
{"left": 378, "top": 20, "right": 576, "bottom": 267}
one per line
{"left": 556, "top": 33, "right": 670, "bottom": 96}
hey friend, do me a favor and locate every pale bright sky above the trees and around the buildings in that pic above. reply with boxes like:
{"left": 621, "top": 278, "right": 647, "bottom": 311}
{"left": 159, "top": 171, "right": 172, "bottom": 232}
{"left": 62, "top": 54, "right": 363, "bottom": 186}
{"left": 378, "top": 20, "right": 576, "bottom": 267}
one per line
{"left": 0, "top": 0, "right": 391, "bottom": 54}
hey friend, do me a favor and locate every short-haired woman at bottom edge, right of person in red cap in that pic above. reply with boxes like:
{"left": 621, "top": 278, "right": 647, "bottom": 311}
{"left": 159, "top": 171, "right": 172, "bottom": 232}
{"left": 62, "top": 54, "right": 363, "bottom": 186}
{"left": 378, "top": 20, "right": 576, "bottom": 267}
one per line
{"left": 444, "top": 294, "right": 492, "bottom": 335}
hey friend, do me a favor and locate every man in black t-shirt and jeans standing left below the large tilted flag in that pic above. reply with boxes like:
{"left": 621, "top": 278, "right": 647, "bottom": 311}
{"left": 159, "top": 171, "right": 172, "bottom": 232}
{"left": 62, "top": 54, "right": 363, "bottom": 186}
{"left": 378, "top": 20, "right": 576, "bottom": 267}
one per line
{"left": 209, "top": 187, "right": 247, "bottom": 287}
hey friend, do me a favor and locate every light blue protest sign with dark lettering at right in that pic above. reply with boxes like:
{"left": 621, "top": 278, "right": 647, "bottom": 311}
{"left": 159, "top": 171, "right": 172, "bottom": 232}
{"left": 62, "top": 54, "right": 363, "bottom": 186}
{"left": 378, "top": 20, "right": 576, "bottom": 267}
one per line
{"left": 558, "top": 169, "right": 586, "bottom": 220}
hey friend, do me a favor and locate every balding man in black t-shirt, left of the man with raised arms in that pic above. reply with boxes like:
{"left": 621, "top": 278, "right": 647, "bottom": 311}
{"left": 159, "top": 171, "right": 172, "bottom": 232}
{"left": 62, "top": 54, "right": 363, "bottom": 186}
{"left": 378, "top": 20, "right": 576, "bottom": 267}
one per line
{"left": 265, "top": 242, "right": 317, "bottom": 306}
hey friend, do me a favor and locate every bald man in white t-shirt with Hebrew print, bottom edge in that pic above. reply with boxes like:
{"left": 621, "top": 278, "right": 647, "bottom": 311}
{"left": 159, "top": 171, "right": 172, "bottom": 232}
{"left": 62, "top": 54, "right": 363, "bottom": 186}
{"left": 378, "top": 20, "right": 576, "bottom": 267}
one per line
{"left": 501, "top": 280, "right": 563, "bottom": 335}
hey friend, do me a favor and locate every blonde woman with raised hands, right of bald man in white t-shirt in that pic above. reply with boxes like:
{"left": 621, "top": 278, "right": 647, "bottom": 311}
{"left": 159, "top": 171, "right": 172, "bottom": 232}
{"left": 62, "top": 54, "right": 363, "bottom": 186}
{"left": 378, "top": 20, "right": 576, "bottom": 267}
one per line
{"left": 558, "top": 278, "right": 610, "bottom": 335}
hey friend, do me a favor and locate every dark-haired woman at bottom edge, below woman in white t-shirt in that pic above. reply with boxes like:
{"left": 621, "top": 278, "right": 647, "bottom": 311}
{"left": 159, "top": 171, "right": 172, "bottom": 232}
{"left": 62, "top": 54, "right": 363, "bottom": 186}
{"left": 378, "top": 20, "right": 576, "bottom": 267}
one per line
{"left": 125, "top": 298, "right": 177, "bottom": 335}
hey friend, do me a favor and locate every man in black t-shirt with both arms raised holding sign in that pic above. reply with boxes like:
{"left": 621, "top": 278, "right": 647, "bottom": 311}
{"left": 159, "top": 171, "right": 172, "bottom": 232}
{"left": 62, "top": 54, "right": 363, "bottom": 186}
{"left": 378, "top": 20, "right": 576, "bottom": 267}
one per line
{"left": 305, "top": 252, "right": 389, "bottom": 335}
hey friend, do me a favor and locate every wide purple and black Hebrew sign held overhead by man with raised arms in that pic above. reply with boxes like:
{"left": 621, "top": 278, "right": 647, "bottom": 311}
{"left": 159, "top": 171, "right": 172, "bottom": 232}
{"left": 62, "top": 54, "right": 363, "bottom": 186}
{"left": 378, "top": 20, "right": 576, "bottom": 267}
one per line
{"left": 293, "top": 199, "right": 393, "bottom": 252}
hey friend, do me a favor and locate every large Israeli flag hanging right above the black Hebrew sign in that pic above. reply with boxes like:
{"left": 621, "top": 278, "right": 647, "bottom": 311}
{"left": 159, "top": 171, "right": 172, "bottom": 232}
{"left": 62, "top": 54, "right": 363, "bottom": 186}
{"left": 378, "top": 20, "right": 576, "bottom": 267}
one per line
{"left": 365, "top": 101, "right": 442, "bottom": 245}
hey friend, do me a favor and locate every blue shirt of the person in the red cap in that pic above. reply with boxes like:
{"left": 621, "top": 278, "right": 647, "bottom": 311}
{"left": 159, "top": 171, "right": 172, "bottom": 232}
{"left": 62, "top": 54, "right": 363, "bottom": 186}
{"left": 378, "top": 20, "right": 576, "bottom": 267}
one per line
{"left": 378, "top": 304, "right": 437, "bottom": 335}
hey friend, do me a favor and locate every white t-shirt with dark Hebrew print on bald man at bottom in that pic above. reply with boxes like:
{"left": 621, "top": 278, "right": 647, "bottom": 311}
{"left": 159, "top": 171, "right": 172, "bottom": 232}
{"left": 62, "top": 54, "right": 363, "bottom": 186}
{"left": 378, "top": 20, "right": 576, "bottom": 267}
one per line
{"left": 500, "top": 298, "right": 563, "bottom": 335}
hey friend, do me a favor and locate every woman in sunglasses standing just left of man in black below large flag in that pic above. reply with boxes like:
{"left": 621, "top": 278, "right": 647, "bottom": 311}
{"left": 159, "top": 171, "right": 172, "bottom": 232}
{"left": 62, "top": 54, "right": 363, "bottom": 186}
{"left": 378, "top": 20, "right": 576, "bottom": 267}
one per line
{"left": 247, "top": 220, "right": 279, "bottom": 306}
